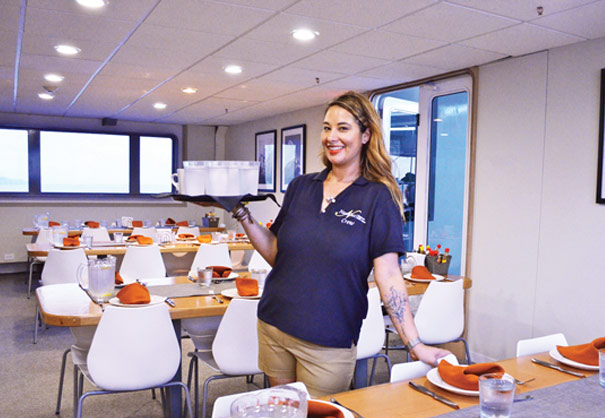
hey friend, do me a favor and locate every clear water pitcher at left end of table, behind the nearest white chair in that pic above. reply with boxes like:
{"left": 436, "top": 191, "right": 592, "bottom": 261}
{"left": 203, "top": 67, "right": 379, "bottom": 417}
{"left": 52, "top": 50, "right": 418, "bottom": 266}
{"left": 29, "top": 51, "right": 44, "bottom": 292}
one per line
{"left": 77, "top": 255, "right": 116, "bottom": 303}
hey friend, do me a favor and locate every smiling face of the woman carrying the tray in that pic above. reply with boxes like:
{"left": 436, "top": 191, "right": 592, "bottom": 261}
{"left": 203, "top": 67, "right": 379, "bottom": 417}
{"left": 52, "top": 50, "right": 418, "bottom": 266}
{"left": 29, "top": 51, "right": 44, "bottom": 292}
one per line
{"left": 321, "top": 106, "right": 370, "bottom": 172}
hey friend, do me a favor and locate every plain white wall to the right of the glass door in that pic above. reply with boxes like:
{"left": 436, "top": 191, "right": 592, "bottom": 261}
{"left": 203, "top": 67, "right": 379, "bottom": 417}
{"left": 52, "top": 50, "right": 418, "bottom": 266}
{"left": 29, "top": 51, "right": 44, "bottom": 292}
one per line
{"left": 468, "top": 39, "right": 605, "bottom": 361}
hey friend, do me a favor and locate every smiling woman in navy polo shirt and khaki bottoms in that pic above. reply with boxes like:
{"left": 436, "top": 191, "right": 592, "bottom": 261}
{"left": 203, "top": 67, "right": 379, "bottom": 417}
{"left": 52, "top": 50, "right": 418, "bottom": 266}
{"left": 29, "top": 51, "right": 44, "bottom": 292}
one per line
{"left": 234, "top": 92, "right": 449, "bottom": 396}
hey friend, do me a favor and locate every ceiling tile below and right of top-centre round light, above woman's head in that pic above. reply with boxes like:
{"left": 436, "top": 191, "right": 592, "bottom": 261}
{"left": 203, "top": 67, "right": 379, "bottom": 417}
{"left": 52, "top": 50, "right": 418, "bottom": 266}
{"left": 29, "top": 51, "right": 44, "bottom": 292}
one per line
{"left": 293, "top": 50, "right": 390, "bottom": 75}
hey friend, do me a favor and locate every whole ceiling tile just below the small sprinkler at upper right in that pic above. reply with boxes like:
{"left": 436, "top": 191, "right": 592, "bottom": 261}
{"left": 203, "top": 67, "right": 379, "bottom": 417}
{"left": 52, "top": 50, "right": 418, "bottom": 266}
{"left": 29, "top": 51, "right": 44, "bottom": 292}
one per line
{"left": 460, "top": 23, "right": 583, "bottom": 56}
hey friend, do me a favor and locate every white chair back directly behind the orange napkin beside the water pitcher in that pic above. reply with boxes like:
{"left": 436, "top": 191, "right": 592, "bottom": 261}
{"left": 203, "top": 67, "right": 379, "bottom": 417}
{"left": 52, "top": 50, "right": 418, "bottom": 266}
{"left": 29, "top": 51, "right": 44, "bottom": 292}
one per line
{"left": 120, "top": 244, "right": 166, "bottom": 283}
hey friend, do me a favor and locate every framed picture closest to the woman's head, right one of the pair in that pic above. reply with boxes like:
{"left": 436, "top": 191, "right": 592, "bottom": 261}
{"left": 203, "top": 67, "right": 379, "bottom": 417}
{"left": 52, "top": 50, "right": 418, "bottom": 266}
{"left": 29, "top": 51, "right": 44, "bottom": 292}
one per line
{"left": 280, "top": 125, "right": 307, "bottom": 192}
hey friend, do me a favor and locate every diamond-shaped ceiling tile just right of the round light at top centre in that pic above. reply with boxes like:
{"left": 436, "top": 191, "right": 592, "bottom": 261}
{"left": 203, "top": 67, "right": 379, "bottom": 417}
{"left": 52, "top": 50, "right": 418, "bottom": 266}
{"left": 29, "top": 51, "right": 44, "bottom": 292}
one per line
{"left": 331, "top": 31, "right": 445, "bottom": 61}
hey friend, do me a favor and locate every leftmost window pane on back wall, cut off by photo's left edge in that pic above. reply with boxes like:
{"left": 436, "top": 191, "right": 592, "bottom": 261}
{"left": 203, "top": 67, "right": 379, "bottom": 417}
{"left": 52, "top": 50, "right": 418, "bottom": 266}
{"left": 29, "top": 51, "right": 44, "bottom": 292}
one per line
{"left": 0, "top": 129, "right": 29, "bottom": 192}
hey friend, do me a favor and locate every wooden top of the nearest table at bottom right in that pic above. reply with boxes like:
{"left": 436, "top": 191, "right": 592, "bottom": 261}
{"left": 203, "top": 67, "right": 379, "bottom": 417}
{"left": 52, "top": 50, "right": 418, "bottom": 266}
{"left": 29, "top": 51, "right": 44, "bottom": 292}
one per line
{"left": 321, "top": 353, "right": 597, "bottom": 418}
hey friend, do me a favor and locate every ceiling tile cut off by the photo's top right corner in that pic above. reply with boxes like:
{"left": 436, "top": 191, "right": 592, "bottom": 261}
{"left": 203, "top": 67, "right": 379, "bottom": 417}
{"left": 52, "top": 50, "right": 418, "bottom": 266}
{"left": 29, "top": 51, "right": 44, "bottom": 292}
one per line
{"left": 533, "top": 1, "right": 605, "bottom": 39}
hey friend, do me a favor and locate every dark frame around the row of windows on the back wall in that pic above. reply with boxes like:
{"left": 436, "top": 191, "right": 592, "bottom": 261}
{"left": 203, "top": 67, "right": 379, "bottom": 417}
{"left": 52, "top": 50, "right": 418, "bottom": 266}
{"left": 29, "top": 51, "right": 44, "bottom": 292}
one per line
{"left": 0, "top": 125, "right": 179, "bottom": 201}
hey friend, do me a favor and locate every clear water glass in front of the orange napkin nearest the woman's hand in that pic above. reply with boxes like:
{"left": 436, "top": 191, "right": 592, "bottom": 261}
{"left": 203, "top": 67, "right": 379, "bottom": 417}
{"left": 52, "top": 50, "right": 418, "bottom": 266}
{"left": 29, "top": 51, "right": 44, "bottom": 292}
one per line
{"left": 479, "top": 373, "right": 515, "bottom": 418}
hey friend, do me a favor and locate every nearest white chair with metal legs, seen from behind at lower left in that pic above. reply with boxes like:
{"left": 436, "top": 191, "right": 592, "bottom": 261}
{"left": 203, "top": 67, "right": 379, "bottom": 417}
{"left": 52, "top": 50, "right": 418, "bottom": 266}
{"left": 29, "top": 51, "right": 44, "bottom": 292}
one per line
{"left": 74, "top": 303, "right": 193, "bottom": 417}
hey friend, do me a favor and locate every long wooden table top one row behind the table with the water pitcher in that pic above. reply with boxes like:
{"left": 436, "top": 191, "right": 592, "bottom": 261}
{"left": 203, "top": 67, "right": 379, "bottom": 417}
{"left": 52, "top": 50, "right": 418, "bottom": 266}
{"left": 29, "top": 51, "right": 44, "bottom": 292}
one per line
{"left": 25, "top": 241, "right": 254, "bottom": 257}
